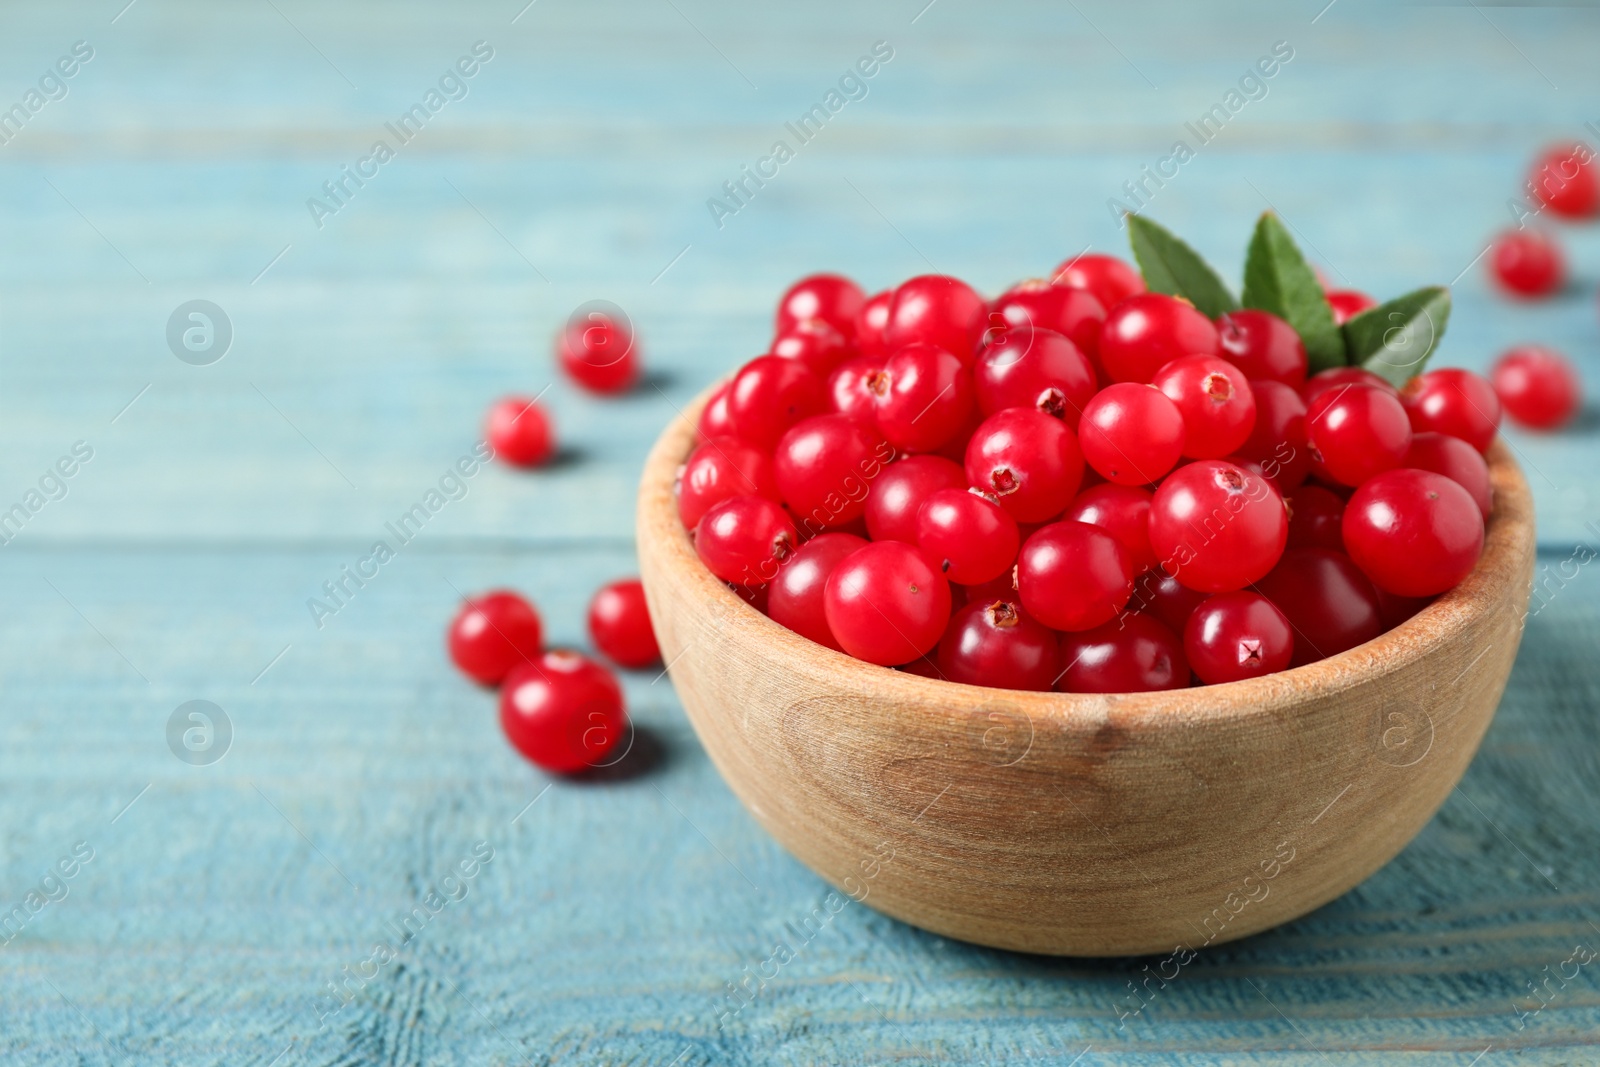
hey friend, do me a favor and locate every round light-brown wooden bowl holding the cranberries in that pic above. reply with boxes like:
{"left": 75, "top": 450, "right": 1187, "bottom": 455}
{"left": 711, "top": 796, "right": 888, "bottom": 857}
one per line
{"left": 638, "top": 395, "right": 1534, "bottom": 963}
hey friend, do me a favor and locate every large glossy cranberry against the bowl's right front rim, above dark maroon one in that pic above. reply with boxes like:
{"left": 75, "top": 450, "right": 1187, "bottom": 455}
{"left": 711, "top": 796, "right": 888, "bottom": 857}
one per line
{"left": 1344, "top": 469, "right": 1483, "bottom": 597}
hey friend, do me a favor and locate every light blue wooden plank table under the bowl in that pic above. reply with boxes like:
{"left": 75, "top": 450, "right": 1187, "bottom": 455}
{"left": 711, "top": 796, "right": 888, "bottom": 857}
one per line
{"left": 0, "top": 0, "right": 1600, "bottom": 1067}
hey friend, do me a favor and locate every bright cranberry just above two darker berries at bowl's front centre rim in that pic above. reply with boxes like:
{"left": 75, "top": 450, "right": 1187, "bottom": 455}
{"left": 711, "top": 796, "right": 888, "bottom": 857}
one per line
{"left": 1016, "top": 522, "right": 1133, "bottom": 630}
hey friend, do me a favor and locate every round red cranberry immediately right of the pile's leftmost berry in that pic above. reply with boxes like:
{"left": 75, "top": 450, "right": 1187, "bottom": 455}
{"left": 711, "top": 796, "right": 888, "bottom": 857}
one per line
{"left": 773, "top": 414, "right": 894, "bottom": 530}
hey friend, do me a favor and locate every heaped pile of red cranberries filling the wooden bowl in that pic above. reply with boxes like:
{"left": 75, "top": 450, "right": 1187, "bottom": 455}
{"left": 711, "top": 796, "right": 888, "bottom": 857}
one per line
{"left": 677, "top": 247, "right": 1548, "bottom": 693}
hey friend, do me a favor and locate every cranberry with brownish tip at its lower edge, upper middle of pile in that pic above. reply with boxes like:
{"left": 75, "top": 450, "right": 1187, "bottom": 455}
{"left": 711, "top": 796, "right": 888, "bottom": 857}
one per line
{"left": 973, "top": 323, "right": 1094, "bottom": 430}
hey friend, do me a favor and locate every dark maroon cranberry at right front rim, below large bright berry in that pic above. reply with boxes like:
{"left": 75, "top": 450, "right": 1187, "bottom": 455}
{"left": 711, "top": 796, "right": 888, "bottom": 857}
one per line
{"left": 1256, "top": 549, "right": 1382, "bottom": 667}
